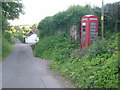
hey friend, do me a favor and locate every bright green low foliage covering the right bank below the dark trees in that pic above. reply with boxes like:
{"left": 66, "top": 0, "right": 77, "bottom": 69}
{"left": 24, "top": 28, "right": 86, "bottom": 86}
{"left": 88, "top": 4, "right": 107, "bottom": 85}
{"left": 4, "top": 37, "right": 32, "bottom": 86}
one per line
{"left": 34, "top": 34, "right": 120, "bottom": 88}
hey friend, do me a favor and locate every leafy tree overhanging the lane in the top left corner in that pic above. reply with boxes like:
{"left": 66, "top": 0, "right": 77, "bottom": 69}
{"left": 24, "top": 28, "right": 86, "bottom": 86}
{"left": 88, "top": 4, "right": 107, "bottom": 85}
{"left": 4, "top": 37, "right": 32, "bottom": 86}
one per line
{"left": 0, "top": 1, "right": 24, "bottom": 31}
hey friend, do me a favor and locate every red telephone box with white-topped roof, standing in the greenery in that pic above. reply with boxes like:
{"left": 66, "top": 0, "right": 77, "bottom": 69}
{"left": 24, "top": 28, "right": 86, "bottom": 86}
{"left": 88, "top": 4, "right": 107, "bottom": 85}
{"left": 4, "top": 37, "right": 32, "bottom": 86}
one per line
{"left": 80, "top": 15, "right": 98, "bottom": 48}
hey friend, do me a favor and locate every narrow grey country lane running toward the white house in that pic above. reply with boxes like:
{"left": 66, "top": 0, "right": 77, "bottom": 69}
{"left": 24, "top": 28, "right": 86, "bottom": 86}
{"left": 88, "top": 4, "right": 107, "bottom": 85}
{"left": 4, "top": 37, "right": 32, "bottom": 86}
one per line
{"left": 2, "top": 39, "right": 71, "bottom": 88}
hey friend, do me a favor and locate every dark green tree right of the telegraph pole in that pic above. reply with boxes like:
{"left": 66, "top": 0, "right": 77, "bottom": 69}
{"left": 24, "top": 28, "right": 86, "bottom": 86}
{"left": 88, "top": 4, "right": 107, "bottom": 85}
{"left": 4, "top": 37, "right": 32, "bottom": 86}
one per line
{"left": 105, "top": 2, "right": 120, "bottom": 32}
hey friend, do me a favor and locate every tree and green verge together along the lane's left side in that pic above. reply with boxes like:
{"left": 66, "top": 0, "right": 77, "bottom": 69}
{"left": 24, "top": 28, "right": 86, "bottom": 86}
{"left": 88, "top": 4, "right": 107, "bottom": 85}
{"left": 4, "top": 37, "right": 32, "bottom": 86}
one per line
{"left": 0, "top": 1, "right": 23, "bottom": 58}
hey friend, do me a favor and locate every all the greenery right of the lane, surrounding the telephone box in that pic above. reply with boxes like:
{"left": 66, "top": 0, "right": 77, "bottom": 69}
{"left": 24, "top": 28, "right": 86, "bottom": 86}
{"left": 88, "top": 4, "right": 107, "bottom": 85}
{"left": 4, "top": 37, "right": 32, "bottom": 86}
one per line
{"left": 34, "top": 2, "right": 120, "bottom": 88}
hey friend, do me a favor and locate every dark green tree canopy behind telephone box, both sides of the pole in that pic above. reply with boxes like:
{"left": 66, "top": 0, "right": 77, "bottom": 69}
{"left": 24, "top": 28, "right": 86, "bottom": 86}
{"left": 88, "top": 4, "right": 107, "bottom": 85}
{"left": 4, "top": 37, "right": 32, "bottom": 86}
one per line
{"left": 38, "top": 2, "right": 120, "bottom": 38}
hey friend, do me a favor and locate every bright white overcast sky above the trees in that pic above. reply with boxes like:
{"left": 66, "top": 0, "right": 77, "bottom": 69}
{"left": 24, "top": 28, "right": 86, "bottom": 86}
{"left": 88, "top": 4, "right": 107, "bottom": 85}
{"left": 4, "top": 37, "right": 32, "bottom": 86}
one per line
{"left": 9, "top": 0, "right": 119, "bottom": 25}
